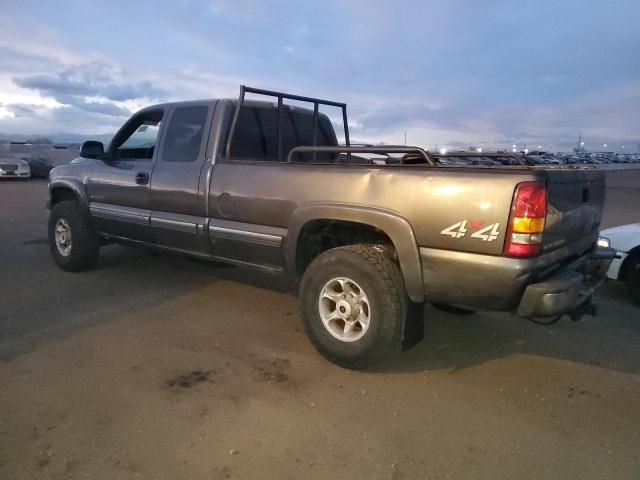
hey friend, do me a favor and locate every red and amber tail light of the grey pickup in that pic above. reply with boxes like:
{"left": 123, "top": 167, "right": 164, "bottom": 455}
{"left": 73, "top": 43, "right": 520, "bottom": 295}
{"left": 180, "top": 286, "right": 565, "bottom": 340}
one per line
{"left": 504, "top": 182, "right": 547, "bottom": 257}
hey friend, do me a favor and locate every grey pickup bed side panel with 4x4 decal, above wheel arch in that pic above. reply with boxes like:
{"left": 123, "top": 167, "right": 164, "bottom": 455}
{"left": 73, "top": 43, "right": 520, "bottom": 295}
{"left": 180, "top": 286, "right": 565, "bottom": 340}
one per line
{"left": 211, "top": 162, "right": 532, "bottom": 255}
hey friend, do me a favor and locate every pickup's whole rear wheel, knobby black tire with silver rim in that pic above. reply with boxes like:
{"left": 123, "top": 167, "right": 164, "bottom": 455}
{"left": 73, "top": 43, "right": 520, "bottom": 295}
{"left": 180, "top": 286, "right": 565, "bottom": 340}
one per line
{"left": 299, "top": 245, "right": 409, "bottom": 369}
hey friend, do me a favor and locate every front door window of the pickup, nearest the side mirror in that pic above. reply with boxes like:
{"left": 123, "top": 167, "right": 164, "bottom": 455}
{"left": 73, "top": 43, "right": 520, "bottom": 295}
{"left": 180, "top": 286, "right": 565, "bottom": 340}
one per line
{"left": 112, "top": 110, "right": 162, "bottom": 160}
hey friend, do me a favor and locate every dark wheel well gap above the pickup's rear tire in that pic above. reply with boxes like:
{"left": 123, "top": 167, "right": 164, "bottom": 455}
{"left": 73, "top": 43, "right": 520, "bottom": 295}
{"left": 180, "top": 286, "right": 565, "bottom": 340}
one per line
{"left": 296, "top": 219, "right": 395, "bottom": 275}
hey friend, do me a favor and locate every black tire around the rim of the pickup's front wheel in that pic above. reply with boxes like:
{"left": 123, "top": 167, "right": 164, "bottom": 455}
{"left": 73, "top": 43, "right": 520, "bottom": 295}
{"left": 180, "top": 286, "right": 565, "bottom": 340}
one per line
{"left": 48, "top": 201, "right": 100, "bottom": 272}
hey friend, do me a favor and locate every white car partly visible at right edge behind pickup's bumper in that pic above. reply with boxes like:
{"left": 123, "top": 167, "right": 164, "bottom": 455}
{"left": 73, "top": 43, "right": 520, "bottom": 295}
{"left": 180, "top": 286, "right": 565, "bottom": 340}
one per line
{"left": 600, "top": 223, "right": 640, "bottom": 304}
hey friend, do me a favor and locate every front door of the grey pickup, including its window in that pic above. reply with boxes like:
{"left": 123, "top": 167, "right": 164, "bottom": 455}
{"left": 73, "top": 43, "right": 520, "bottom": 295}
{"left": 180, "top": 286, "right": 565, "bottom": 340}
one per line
{"left": 87, "top": 109, "right": 165, "bottom": 241}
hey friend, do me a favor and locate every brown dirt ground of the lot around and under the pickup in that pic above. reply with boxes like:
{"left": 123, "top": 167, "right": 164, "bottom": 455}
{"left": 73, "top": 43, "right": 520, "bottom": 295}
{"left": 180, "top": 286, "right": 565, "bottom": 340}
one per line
{"left": 0, "top": 171, "right": 640, "bottom": 480}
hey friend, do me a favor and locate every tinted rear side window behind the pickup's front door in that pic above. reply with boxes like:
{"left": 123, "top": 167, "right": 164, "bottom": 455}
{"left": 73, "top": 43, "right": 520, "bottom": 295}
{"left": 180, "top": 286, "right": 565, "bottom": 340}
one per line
{"left": 162, "top": 106, "right": 208, "bottom": 162}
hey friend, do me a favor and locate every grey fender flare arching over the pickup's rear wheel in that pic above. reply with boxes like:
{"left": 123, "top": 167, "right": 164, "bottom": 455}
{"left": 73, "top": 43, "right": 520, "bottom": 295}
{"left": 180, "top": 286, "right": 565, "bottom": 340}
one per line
{"left": 285, "top": 203, "right": 424, "bottom": 302}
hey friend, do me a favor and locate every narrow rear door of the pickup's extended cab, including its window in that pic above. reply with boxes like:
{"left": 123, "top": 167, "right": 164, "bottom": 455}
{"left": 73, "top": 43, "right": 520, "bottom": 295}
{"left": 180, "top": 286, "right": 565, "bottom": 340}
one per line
{"left": 151, "top": 102, "right": 215, "bottom": 254}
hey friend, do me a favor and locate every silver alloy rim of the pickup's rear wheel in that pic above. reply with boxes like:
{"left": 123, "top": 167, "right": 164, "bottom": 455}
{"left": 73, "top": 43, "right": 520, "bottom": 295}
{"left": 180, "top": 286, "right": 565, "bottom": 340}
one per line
{"left": 318, "top": 277, "right": 371, "bottom": 342}
